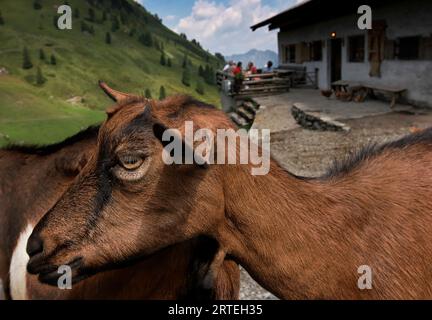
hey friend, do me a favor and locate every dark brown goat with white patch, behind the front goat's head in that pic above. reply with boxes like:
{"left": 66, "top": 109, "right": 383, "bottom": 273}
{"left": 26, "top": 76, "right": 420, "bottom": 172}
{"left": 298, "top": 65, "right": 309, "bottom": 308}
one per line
{"left": 0, "top": 122, "right": 239, "bottom": 299}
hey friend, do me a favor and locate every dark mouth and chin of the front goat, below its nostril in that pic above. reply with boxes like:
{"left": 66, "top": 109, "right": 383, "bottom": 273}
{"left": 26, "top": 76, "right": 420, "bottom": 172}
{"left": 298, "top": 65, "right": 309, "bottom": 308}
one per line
{"left": 27, "top": 257, "right": 90, "bottom": 287}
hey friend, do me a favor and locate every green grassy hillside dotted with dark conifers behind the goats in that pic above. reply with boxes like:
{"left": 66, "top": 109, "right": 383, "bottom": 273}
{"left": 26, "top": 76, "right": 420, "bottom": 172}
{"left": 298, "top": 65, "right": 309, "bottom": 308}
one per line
{"left": 0, "top": 0, "right": 223, "bottom": 145}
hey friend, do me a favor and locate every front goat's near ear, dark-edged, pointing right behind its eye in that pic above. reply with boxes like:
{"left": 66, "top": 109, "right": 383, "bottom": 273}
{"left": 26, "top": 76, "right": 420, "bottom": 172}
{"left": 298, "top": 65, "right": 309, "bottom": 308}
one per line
{"left": 153, "top": 122, "right": 209, "bottom": 169}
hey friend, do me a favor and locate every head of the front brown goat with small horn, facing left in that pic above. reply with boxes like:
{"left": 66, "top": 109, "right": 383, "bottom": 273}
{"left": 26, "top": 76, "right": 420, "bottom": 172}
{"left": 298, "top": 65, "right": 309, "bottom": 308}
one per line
{"left": 27, "top": 83, "right": 231, "bottom": 285}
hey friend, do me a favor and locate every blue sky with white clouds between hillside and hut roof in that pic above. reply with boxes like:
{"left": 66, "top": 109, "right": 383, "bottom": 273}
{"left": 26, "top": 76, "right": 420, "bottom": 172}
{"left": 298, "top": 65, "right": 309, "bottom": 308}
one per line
{"left": 136, "top": 0, "right": 301, "bottom": 55}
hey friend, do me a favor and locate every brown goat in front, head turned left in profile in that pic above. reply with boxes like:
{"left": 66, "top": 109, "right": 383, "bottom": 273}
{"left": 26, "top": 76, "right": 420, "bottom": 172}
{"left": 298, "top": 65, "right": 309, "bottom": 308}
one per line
{"left": 27, "top": 87, "right": 432, "bottom": 299}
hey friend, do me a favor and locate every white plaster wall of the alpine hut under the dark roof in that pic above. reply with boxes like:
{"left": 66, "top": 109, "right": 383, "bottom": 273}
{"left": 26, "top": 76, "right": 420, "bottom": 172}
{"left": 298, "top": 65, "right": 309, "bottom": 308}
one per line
{"left": 278, "top": 0, "right": 432, "bottom": 107}
